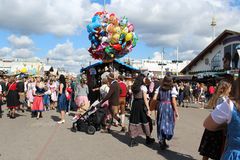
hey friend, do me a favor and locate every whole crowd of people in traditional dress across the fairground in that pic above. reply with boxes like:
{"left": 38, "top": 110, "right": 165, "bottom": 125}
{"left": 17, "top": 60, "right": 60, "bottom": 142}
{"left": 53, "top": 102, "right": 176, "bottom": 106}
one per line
{"left": 0, "top": 72, "right": 240, "bottom": 160}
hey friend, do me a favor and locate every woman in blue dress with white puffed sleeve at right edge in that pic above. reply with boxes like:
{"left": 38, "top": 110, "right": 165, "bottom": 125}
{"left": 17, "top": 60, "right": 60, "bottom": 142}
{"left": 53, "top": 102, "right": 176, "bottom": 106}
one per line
{"left": 203, "top": 79, "right": 240, "bottom": 160}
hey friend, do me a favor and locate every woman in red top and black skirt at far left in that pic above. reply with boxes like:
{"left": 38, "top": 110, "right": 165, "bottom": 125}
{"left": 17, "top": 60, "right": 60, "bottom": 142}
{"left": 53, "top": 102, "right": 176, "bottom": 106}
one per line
{"left": 6, "top": 77, "right": 20, "bottom": 118}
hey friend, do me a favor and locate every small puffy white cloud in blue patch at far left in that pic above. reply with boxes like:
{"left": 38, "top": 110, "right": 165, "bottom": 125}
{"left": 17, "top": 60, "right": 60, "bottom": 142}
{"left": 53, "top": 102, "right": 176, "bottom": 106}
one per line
{"left": 8, "top": 35, "right": 33, "bottom": 48}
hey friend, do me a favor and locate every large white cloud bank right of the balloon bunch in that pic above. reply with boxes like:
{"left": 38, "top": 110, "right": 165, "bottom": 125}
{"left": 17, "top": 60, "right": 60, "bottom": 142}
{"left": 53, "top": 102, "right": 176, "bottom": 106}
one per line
{"left": 107, "top": 0, "right": 240, "bottom": 51}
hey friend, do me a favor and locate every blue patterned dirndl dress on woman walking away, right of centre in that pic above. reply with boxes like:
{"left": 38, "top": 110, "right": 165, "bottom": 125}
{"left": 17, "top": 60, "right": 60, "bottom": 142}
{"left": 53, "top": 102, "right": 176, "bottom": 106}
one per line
{"left": 157, "top": 89, "right": 175, "bottom": 142}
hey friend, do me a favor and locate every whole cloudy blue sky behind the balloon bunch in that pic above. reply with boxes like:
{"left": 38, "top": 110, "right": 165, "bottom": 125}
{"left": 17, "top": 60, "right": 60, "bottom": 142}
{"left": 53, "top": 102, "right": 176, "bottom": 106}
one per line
{"left": 0, "top": 0, "right": 240, "bottom": 69}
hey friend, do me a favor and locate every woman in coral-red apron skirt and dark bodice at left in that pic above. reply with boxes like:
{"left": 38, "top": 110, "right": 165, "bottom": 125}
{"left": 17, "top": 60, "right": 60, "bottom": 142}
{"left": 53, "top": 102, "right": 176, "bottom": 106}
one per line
{"left": 32, "top": 77, "right": 45, "bottom": 119}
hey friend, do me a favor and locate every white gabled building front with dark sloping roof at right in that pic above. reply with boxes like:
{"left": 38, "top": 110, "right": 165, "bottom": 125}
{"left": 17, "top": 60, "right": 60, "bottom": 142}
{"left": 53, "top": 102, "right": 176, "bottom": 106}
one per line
{"left": 181, "top": 30, "right": 240, "bottom": 76}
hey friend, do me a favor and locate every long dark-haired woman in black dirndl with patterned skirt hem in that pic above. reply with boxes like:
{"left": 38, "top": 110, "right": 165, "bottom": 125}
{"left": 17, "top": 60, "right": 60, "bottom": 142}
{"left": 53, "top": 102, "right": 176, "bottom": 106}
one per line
{"left": 129, "top": 74, "right": 155, "bottom": 147}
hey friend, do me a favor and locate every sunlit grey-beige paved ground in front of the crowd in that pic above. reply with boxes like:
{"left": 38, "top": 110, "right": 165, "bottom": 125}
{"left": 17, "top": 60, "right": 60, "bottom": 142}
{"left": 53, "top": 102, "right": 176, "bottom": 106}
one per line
{"left": 0, "top": 106, "right": 209, "bottom": 160}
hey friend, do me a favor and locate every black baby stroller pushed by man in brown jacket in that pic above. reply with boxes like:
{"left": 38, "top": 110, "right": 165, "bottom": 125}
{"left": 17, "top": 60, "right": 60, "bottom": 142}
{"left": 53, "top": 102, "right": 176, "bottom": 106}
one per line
{"left": 72, "top": 103, "right": 106, "bottom": 135}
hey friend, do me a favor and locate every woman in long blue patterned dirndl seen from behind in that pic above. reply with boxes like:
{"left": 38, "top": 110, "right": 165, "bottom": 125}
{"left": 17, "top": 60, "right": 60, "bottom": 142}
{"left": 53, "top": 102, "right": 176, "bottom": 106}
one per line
{"left": 153, "top": 75, "right": 178, "bottom": 150}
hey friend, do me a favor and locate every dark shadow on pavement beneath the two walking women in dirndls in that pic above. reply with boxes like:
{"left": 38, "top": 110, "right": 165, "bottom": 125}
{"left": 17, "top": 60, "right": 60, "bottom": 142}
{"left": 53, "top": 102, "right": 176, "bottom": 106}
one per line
{"left": 111, "top": 131, "right": 196, "bottom": 160}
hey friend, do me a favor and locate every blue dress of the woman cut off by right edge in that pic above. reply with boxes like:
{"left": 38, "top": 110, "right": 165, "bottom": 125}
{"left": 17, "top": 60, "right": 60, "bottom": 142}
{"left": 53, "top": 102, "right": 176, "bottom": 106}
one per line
{"left": 221, "top": 107, "right": 240, "bottom": 160}
